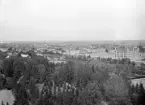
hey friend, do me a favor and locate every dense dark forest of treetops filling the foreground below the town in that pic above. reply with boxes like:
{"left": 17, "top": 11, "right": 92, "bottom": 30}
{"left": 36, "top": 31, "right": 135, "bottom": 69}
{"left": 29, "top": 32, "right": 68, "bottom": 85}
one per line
{"left": 0, "top": 51, "right": 145, "bottom": 105}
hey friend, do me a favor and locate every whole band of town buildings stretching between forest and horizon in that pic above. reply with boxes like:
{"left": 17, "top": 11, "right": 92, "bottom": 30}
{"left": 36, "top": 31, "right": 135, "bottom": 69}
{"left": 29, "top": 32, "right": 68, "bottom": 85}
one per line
{"left": 0, "top": 44, "right": 145, "bottom": 63}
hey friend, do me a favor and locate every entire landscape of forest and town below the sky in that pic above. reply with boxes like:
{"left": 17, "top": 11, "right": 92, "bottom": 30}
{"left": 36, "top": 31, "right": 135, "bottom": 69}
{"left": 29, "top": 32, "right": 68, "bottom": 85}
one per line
{"left": 0, "top": 41, "right": 145, "bottom": 105}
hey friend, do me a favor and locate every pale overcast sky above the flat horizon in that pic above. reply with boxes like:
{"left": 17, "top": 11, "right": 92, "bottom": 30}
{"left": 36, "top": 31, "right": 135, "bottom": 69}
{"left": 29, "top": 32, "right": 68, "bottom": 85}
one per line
{"left": 0, "top": 0, "right": 145, "bottom": 41}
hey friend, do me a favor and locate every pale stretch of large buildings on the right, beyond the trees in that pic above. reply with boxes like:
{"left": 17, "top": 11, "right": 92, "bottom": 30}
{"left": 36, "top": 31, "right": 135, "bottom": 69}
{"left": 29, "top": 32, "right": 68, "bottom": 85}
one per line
{"left": 64, "top": 46, "right": 145, "bottom": 61}
